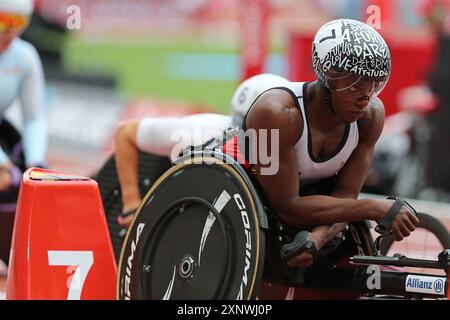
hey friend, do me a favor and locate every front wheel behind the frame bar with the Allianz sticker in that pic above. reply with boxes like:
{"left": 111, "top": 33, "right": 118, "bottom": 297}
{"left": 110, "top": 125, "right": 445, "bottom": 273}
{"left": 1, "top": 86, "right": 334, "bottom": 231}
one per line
{"left": 380, "top": 212, "right": 450, "bottom": 274}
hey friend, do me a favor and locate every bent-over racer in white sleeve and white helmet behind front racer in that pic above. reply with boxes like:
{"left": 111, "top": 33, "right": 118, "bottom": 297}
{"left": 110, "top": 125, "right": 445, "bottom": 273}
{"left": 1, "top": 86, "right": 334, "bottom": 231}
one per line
{"left": 116, "top": 73, "right": 290, "bottom": 226}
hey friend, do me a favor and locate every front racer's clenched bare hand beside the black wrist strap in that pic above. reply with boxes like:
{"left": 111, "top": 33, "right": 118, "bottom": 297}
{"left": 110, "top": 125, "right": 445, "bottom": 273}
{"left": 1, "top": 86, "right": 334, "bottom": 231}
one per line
{"left": 377, "top": 200, "right": 419, "bottom": 241}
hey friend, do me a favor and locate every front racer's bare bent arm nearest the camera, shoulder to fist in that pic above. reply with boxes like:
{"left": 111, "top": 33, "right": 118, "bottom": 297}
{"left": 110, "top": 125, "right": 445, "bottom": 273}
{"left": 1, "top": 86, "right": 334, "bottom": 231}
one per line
{"left": 246, "top": 89, "right": 415, "bottom": 239}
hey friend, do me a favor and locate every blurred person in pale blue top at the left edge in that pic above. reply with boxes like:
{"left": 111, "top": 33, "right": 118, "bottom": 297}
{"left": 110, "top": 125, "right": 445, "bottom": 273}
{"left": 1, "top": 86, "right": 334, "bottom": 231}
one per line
{"left": 0, "top": 0, "right": 47, "bottom": 199}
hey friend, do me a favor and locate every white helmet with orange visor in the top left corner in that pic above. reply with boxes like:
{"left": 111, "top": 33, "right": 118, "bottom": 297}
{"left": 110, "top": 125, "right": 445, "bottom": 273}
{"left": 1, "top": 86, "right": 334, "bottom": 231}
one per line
{"left": 0, "top": 0, "right": 34, "bottom": 31}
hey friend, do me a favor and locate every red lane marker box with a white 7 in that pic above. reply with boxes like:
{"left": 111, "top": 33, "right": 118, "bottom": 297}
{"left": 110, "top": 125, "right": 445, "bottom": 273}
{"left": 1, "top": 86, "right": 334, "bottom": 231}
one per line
{"left": 6, "top": 168, "right": 117, "bottom": 300}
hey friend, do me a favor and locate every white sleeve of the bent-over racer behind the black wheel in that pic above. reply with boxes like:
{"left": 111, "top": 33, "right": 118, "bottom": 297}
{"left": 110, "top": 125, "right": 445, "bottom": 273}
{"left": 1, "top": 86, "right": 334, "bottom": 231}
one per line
{"left": 136, "top": 113, "right": 231, "bottom": 160}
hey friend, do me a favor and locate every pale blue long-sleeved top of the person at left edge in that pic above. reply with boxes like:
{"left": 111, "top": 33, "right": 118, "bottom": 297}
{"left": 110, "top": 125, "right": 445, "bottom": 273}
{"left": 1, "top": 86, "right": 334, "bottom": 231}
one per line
{"left": 0, "top": 39, "right": 47, "bottom": 166}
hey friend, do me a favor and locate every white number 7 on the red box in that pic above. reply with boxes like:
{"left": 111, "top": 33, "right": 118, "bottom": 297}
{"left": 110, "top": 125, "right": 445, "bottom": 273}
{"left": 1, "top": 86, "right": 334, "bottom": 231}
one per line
{"left": 48, "top": 250, "right": 94, "bottom": 300}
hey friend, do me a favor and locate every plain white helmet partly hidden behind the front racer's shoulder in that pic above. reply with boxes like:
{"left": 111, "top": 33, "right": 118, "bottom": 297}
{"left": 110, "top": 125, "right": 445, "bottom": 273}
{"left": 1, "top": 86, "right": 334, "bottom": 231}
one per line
{"left": 231, "top": 73, "right": 289, "bottom": 126}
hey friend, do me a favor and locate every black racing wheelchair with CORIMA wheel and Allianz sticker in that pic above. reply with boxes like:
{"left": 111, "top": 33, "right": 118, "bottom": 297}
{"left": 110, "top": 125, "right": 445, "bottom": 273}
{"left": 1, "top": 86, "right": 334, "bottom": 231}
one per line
{"left": 97, "top": 130, "right": 450, "bottom": 299}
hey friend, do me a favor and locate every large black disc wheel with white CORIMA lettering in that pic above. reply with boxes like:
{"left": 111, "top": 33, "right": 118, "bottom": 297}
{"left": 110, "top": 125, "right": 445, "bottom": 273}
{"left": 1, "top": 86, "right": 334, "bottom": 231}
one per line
{"left": 117, "top": 158, "right": 264, "bottom": 300}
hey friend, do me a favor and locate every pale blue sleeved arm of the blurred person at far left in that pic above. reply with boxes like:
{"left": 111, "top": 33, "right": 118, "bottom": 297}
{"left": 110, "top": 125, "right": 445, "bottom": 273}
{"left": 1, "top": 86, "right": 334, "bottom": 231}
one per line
{"left": 20, "top": 44, "right": 48, "bottom": 166}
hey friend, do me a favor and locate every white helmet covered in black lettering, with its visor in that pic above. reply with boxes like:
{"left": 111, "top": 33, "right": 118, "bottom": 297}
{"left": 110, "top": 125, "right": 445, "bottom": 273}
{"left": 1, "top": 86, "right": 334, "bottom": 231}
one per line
{"left": 312, "top": 19, "right": 391, "bottom": 100}
